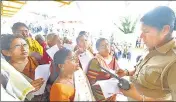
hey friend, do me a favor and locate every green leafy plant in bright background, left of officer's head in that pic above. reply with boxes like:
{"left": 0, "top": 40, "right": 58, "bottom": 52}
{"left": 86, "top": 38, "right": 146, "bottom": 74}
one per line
{"left": 118, "top": 17, "right": 137, "bottom": 34}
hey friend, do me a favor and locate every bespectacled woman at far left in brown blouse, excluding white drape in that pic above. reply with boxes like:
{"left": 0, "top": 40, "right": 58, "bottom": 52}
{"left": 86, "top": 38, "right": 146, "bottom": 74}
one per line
{"left": 1, "top": 34, "right": 44, "bottom": 100}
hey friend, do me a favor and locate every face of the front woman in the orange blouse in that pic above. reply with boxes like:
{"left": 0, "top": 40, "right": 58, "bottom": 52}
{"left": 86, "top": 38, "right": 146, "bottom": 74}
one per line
{"left": 64, "top": 52, "right": 77, "bottom": 73}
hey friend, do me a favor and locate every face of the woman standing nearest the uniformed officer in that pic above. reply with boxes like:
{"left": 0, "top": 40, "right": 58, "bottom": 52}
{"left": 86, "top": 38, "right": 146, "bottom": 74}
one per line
{"left": 98, "top": 40, "right": 110, "bottom": 57}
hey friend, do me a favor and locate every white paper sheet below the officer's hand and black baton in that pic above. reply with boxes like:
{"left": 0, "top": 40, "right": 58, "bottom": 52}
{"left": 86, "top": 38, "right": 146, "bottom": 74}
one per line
{"left": 95, "top": 78, "right": 120, "bottom": 98}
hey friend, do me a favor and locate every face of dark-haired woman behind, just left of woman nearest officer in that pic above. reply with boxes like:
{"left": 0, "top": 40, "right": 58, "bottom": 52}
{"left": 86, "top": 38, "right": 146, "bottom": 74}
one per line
{"left": 78, "top": 35, "right": 88, "bottom": 48}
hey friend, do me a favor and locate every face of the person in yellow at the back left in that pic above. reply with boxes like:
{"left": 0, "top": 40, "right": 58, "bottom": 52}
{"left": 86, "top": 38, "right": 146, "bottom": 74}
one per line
{"left": 15, "top": 26, "right": 29, "bottom": 38}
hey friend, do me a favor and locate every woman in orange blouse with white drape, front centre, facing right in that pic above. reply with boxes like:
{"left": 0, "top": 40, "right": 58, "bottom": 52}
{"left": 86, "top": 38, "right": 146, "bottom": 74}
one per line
{"left": 50, "top": 48, "right": 93, "bottom": 101}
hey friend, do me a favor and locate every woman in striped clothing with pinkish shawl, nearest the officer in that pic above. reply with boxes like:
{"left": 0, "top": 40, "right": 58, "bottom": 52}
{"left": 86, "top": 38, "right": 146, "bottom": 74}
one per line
{"left": 87, "top": 38, "right": 118, "bottom": 101}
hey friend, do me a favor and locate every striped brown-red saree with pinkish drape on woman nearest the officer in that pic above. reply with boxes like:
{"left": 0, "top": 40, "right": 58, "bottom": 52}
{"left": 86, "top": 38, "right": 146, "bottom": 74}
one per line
{"left": 87, "top": 54, "right": 118, "bottom": 101}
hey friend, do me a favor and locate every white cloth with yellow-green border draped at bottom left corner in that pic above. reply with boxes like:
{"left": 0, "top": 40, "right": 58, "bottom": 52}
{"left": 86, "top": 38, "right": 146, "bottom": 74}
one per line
{"left": 1, "top": 58, "right": 34, "bottom": 101}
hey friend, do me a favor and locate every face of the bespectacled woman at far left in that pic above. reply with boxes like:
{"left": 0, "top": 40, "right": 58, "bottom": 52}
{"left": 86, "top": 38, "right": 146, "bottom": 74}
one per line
{"left": 9, "top": 38, "right": 29, "bottom": 59}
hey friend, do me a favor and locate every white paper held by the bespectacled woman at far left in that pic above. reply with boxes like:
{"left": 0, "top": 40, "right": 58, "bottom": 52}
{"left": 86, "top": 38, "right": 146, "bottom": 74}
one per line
{"left": 33, "top": 64, "right": 50, "bottom": 95}
